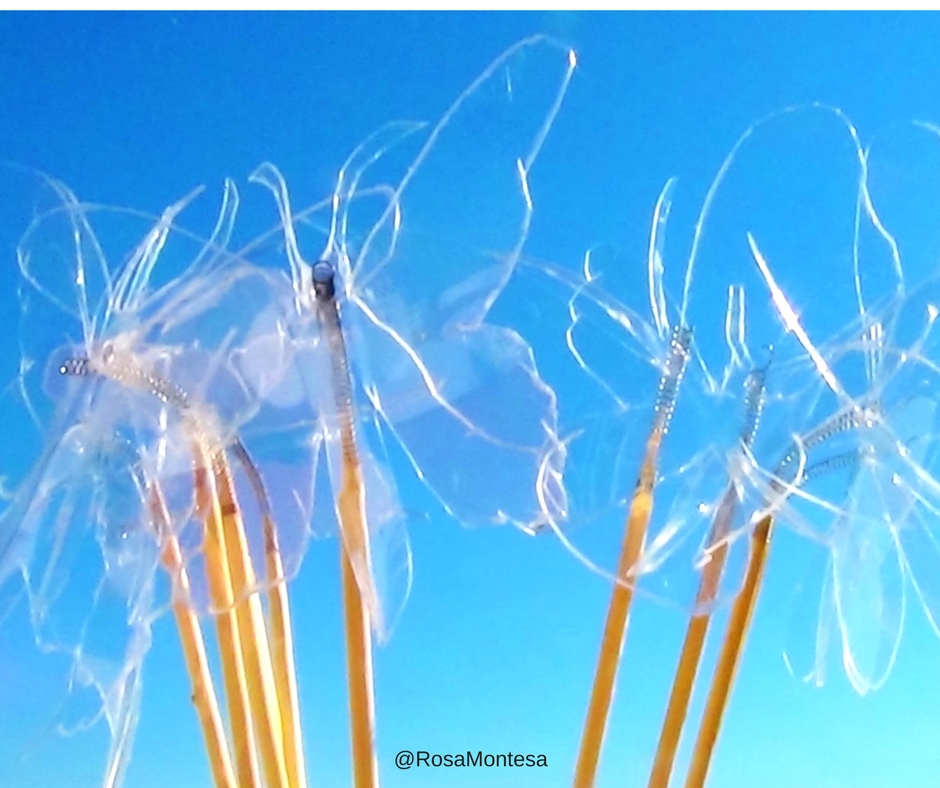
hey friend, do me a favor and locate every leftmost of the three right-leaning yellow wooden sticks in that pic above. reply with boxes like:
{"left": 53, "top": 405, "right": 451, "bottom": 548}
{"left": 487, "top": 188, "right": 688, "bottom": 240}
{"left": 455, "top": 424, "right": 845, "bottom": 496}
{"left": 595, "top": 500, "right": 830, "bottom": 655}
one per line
{"left": 574, "top": 424, "right": 663, "bottom": 788}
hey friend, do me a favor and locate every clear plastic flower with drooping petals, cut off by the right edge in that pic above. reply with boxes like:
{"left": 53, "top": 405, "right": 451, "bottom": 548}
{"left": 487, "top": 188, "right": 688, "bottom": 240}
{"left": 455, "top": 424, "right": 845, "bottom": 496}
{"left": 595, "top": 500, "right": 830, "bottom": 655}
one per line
{"left": 781, "top": 274, "right": 940, "bottom": 693}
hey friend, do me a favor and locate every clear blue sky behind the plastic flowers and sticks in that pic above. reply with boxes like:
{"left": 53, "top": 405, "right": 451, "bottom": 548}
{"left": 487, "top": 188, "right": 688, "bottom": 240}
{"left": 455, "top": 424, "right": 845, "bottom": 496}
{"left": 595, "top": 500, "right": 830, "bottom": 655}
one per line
{"left": 0, "top": 13, "right": 940, "bottom": 788}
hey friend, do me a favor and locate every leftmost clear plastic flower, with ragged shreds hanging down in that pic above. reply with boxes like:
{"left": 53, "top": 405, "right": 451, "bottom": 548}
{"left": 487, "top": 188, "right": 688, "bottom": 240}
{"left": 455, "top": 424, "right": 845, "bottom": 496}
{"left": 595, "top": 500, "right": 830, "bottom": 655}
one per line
{"left": 0, "top": 171, "right": 324, "bottom": 785}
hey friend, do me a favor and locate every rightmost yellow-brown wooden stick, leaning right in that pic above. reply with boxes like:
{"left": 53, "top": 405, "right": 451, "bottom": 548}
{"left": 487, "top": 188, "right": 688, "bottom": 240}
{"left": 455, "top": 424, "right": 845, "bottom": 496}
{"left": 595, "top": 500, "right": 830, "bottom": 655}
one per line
{"left": 685, "top": 514, "right": 773, "bottom": 788}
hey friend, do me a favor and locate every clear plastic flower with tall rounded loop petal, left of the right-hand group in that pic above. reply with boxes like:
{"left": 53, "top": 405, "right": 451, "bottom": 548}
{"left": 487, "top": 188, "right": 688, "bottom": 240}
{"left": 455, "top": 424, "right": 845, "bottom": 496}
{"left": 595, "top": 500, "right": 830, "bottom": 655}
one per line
{"left": 520, "top": 106, "right": 901, "bottom": 608}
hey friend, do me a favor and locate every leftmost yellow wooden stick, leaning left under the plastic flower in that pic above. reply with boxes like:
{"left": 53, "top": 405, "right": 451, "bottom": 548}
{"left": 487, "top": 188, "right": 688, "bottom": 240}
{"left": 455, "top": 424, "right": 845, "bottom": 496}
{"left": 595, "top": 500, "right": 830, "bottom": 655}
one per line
{"left": 150, "top": 482, "right": 236, "bottom": 788}
